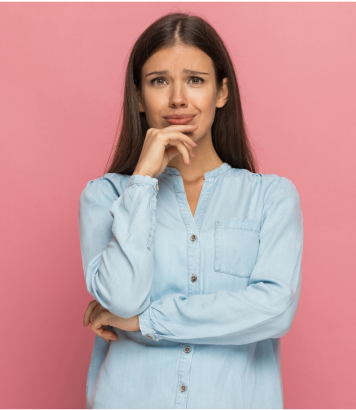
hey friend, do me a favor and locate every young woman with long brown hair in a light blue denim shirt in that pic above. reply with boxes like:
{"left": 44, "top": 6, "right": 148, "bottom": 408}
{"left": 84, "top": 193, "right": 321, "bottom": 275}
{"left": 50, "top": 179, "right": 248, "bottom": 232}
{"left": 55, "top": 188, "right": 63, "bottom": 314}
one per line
{"left": 79, "top": 13, "right": 303, "bottom": 409}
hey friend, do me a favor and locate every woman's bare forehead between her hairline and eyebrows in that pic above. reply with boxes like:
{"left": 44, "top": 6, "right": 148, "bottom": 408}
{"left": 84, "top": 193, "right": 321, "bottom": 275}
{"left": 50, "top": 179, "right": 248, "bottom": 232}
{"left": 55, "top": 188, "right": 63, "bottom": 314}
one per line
{"left": 142, "top": 45, "right": 213, "bottom": 75}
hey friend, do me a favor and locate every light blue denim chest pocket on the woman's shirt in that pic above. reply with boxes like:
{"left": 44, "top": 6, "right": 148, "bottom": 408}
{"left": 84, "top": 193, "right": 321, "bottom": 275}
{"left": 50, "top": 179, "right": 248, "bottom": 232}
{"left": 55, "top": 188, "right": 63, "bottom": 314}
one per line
{"left": 214, "top": 218, "right": 260, "bottom": 278}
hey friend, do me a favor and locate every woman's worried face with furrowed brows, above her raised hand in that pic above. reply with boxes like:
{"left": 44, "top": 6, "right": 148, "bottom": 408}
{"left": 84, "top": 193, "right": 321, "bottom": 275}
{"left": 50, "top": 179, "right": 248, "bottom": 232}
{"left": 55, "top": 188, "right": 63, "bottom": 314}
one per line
{"left": 136, "top": 45, "right": 227, "bottom": 141}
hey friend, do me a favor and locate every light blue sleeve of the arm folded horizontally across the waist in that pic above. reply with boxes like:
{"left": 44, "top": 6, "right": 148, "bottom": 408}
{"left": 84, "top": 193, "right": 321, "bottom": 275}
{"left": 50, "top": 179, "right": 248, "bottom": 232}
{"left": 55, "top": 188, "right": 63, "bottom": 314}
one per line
{"left": 139, "top": 177, "right": 303, "bottom": 345}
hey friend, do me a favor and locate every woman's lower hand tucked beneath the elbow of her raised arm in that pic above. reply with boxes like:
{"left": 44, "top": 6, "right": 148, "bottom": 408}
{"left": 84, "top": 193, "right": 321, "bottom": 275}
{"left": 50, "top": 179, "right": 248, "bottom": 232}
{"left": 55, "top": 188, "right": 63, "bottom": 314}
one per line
{"left": 83, "top": 300, "right": 140, "bottom": 341}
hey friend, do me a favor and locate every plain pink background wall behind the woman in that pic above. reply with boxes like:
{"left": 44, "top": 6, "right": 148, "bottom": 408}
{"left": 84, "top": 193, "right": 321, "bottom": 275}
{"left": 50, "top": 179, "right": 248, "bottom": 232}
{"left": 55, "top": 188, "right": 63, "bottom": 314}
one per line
{"left": 0, "top": 2, "right": 356, "bottom": 408}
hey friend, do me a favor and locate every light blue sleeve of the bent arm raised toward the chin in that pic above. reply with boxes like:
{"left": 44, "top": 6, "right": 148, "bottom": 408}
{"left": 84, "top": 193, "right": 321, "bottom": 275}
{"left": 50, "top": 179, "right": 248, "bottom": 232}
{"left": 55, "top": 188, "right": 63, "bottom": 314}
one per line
{"left": 78, "top": 175, "right": 158, "bottom": 318}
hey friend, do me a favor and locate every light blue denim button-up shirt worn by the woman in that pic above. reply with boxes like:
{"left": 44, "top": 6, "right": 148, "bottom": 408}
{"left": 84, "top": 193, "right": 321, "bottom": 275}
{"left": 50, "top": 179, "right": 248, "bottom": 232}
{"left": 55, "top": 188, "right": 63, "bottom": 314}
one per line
{"left": 79, "top": 162, "right": 303, "bottom": 409}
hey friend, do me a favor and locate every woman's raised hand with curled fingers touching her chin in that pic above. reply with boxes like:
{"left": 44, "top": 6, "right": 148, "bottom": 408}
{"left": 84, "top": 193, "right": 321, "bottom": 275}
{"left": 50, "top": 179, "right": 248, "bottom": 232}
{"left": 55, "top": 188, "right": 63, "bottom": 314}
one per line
{"left": 133, "top": 124, "right": 198, "bottom": 178}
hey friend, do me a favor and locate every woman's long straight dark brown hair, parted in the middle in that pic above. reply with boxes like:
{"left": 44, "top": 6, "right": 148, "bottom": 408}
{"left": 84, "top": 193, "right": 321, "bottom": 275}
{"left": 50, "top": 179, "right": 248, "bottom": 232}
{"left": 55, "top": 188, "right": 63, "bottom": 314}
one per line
{"left": 105, "top": 13, "right": 256, "bottom": 175}
